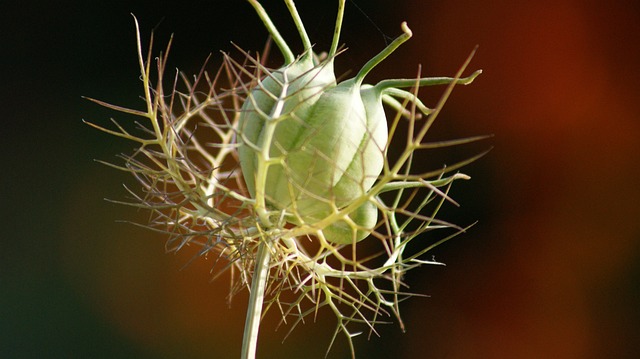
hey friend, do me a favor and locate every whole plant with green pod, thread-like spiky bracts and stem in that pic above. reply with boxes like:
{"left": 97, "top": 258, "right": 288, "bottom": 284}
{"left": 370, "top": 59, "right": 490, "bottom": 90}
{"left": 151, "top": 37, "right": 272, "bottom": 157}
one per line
{"left": 85, "top": 0, "right": 482, "bottom": 358}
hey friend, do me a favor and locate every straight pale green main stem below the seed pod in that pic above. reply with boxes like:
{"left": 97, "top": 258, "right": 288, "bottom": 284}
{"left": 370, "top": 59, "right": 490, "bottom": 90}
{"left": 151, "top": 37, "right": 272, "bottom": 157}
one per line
{"left": 241, "top": 240, "right": 271, "bottom": 359}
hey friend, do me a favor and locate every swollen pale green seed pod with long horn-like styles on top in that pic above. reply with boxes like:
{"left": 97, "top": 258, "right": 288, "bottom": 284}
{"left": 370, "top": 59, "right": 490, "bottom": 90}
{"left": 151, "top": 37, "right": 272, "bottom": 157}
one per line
{"left": 238, "top": 0, "right": 480, "bottom": 244}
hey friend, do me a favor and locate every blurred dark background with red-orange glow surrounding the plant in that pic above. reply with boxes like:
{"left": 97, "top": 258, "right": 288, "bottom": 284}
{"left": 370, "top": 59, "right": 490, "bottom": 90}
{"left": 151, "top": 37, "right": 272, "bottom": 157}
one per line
{"left": 0, "top": 0, "right": 640, "bottom": 359}
